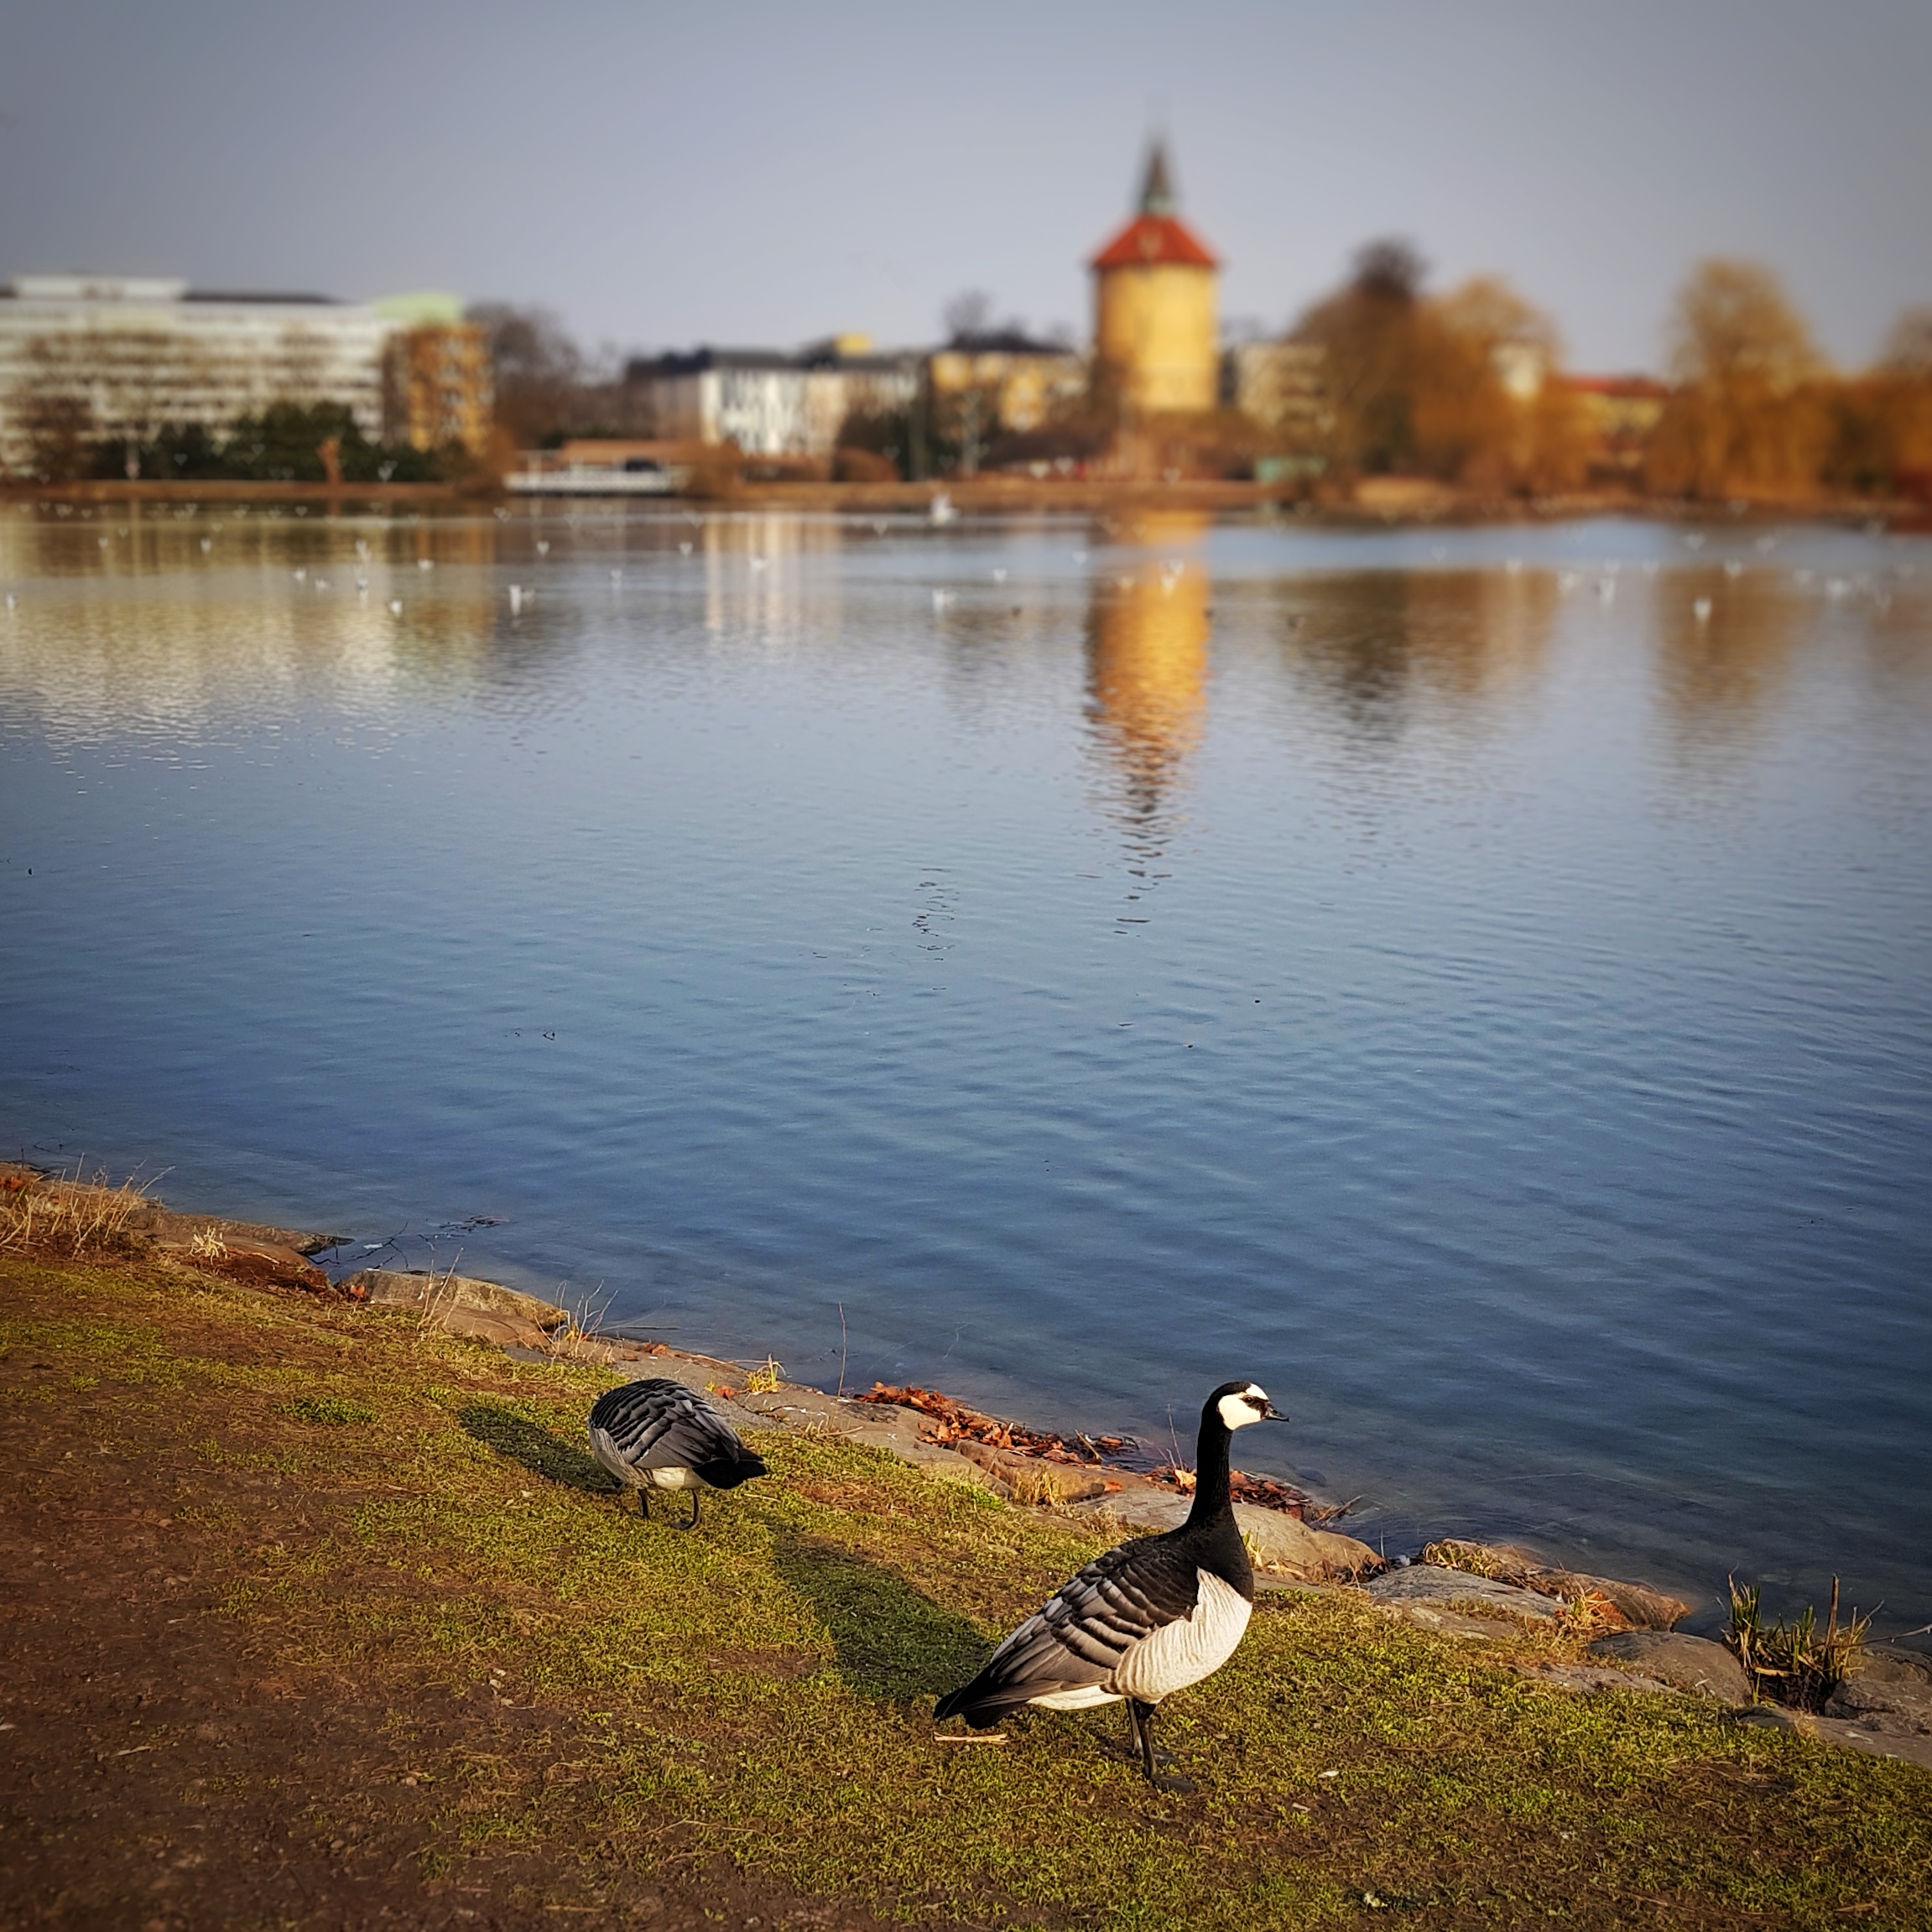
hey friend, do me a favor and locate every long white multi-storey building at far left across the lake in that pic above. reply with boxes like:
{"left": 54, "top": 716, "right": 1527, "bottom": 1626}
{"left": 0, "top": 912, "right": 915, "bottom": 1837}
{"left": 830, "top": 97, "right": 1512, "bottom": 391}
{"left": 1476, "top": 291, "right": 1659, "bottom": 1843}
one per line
{"left": 0, "top": 274, "right": 398, "bottom": 476}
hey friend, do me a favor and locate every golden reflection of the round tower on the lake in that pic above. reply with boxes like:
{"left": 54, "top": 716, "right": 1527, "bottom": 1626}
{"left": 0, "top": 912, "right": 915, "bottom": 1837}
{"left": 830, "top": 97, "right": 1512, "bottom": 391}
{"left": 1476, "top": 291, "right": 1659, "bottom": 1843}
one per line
{"left": 1088, "top": 514, "right": 1207, "bottom": 817}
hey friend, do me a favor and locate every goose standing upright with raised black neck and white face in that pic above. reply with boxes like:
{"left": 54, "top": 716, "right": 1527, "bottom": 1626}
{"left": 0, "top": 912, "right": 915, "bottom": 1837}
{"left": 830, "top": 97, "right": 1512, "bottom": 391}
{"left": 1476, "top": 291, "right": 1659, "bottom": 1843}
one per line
{"left": 933, "top": 1382, "right": 1289, "bottom": 1791}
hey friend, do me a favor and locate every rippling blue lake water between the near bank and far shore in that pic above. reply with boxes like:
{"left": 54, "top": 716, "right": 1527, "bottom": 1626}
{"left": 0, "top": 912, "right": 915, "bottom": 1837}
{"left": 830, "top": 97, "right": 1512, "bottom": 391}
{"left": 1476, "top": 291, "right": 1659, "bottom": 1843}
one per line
{"left": 0, "top": 506, "right": 1932, "bottom": 1628}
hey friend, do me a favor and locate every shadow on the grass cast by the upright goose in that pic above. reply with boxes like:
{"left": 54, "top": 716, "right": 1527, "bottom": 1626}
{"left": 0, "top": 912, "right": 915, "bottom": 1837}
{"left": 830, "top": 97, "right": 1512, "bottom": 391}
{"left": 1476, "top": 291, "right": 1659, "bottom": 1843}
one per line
{"left": 773, "top": 1534, "right": 991, "bottom": 1704}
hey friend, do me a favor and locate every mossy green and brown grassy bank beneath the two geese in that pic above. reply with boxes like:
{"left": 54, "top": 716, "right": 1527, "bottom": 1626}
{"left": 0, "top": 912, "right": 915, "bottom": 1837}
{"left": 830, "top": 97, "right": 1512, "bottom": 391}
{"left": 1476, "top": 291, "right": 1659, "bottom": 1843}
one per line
{"left": 0, "top": 1258, "right": 1932, "bottom": 1932}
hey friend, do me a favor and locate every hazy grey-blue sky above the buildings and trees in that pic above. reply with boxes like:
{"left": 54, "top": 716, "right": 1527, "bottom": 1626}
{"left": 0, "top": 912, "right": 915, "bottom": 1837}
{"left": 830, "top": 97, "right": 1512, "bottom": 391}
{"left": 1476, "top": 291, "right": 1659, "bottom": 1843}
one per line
{"left": 0, "top": 0, "right": 1932, "bottom": 369}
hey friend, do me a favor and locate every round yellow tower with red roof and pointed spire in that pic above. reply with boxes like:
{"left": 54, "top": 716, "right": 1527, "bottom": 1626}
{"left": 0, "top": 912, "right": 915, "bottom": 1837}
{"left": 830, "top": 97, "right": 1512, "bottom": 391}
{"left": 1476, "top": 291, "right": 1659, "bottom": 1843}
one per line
{"left": 1091, "top": 143, "right": 1221, "bottom": 415}
